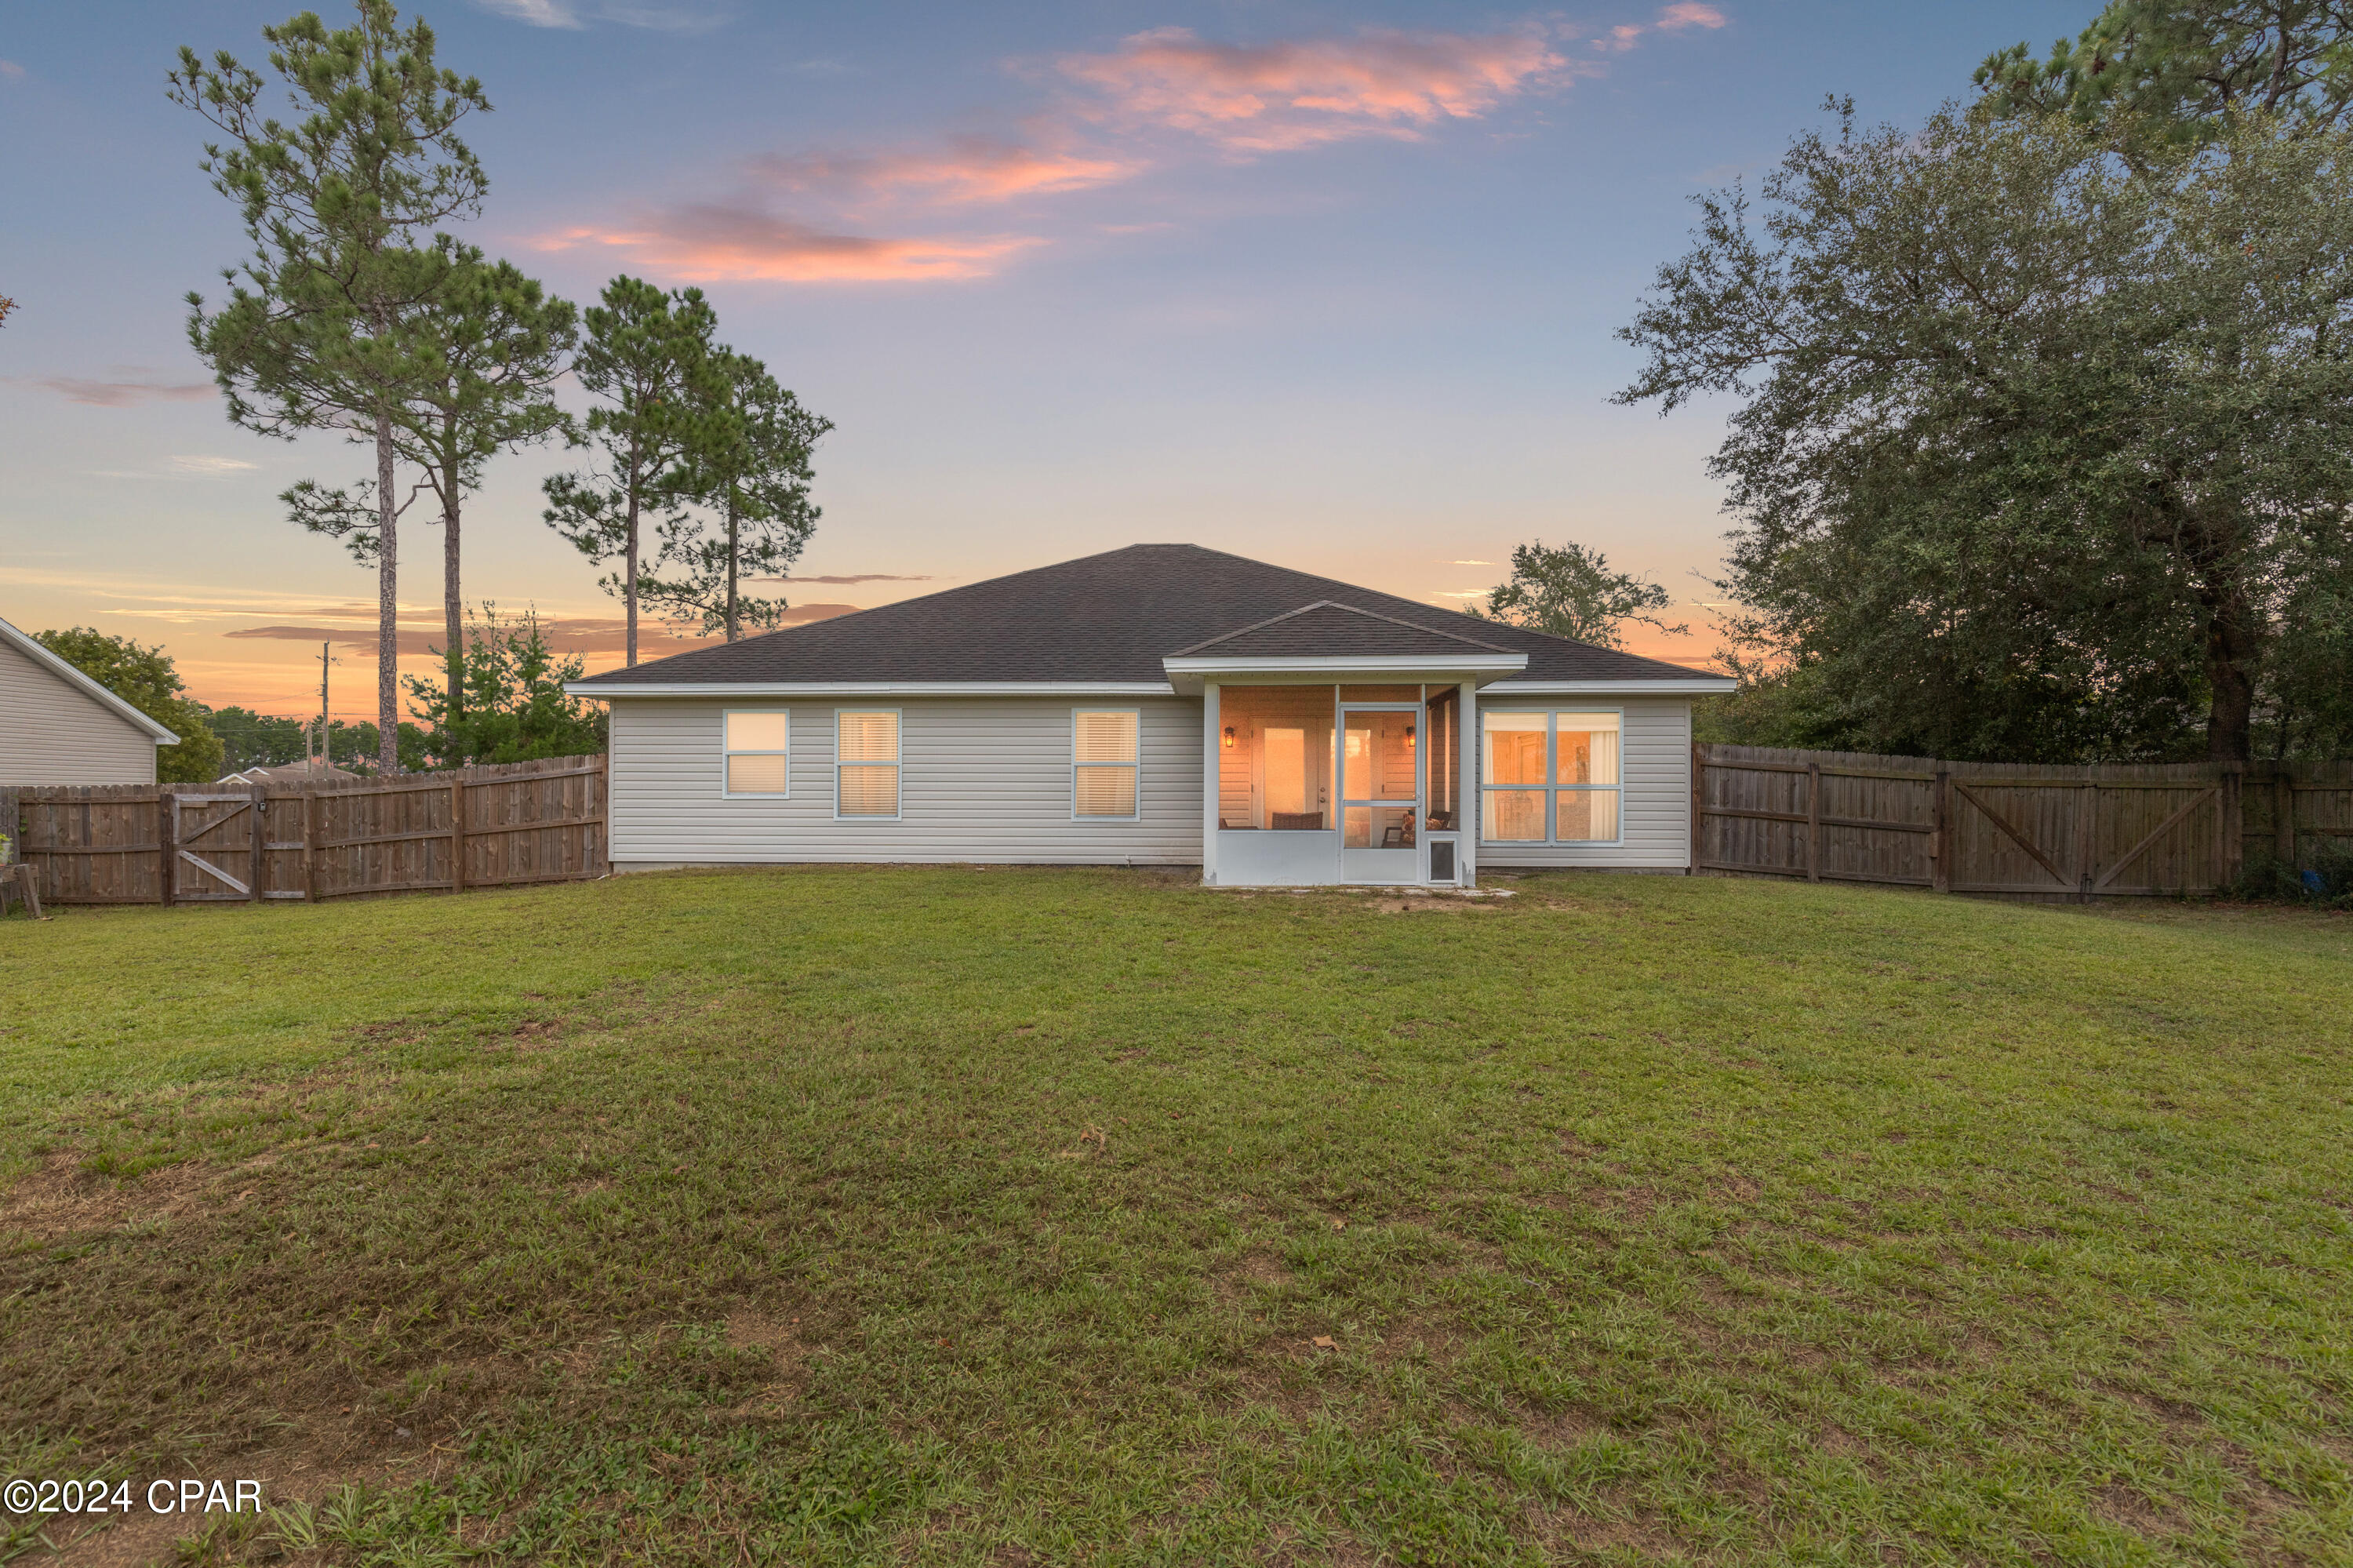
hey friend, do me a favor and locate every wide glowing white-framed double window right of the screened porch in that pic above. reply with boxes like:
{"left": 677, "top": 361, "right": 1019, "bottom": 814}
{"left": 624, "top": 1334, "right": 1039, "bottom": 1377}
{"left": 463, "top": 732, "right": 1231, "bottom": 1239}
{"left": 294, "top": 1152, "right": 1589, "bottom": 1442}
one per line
{"left": 1478, "top": 708, "right": 1626, "bottom": 843}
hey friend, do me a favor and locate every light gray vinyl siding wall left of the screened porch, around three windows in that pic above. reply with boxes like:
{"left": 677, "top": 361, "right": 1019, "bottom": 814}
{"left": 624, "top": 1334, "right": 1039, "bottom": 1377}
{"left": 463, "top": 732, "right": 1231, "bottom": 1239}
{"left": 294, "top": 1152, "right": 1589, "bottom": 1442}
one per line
{"left": 612, "top": 697, "right": 1202, "bottom": 869}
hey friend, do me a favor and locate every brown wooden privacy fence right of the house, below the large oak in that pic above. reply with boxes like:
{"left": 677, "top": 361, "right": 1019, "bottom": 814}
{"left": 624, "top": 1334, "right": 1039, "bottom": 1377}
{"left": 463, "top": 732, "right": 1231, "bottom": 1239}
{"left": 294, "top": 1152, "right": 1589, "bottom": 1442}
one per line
{"left": 1692, "top": 746, "right": 2353, "bottom": 900}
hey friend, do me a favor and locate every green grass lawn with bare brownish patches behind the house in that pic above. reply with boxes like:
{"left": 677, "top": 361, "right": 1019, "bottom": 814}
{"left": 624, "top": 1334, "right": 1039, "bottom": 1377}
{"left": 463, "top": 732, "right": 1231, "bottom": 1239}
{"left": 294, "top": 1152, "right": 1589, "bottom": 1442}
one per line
{"left": 0, "top": 869, "right": 2353, "bottom": 1566}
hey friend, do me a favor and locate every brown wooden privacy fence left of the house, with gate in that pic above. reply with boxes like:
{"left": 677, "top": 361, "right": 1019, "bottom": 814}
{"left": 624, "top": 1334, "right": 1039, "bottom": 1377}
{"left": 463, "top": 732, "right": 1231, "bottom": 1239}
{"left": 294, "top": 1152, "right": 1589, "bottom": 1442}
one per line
{"left": 0, "top": 755, "right": 607, "bottom": 904}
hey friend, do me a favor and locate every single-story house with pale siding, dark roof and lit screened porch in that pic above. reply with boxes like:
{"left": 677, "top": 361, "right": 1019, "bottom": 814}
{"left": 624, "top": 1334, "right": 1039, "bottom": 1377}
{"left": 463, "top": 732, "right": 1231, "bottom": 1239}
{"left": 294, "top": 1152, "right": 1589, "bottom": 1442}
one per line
{"left": 567, "top": 544, "right": 1734, "bottom": 888}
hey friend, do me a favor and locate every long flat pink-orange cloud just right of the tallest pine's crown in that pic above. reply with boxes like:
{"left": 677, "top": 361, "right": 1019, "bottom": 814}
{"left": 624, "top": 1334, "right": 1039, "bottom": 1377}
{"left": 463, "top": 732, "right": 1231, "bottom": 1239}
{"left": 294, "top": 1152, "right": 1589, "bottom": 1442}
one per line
{"left": 534, "top": 202, "right": 1045, "bottom": 282}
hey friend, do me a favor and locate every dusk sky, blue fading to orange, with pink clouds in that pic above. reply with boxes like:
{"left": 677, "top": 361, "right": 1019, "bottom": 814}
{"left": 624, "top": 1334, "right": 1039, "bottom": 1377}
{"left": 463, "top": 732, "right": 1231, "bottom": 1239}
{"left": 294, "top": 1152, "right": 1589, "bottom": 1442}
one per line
{"left": 0, "top": 0, "right": 2097, "bottom": 718}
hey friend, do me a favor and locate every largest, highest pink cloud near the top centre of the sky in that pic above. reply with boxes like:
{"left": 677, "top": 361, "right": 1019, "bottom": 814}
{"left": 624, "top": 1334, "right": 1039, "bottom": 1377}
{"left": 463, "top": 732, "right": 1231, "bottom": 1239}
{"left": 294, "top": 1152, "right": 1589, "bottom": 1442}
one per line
{"left": 1056, "top": 28, "right": 1569, "bottom": 151}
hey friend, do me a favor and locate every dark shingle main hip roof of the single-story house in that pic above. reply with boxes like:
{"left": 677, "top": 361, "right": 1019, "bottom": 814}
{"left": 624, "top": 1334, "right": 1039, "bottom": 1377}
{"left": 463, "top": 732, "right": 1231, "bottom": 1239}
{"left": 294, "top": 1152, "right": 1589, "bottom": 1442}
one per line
{"left": 581, "top": 544, "right": 1699, "bottom": 689}
